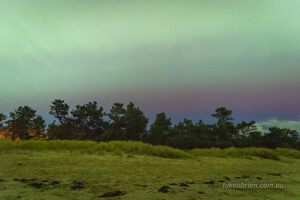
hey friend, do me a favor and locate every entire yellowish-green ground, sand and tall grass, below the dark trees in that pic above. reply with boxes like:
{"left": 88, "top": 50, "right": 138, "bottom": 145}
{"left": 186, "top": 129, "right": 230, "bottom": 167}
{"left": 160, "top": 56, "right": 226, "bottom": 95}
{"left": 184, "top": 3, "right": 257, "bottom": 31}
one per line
{"left": 0, "top": 140, "right": 300, "bottom": 200}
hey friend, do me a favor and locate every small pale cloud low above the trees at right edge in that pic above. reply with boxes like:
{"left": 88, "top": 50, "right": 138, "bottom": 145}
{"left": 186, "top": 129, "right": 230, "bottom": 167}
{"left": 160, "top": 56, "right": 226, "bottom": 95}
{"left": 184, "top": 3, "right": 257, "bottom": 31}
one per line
{"left": 256, "top": 118, "right": 300, "bottom": 132}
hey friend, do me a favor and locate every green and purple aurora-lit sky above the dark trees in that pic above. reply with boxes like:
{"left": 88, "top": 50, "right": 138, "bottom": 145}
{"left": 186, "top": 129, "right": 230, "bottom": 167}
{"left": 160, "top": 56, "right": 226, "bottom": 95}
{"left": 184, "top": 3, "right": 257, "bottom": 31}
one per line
{"left": 0, "top": 0, "right": 300, "bottom": 130}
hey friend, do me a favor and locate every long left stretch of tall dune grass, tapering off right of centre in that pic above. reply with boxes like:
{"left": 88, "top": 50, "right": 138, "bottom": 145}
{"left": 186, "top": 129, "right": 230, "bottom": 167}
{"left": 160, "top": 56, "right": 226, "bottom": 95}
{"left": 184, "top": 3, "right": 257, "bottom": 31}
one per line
{"left": 0, "top": 140, "right": 192, "bottom": 158}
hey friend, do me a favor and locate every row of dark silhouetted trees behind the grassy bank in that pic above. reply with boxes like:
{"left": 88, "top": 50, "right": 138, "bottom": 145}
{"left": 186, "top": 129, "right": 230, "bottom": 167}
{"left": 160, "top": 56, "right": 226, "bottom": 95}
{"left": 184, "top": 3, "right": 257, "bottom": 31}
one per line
{"left": 0, "top": 100, "right": 300, "bottom": 149}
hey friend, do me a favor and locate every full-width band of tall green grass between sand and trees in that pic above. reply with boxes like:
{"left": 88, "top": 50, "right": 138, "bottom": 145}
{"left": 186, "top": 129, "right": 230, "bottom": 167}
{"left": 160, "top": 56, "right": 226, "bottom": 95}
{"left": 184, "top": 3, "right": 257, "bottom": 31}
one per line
{"left": 0, "top": 140, "right": 300, "bottom": 160}
